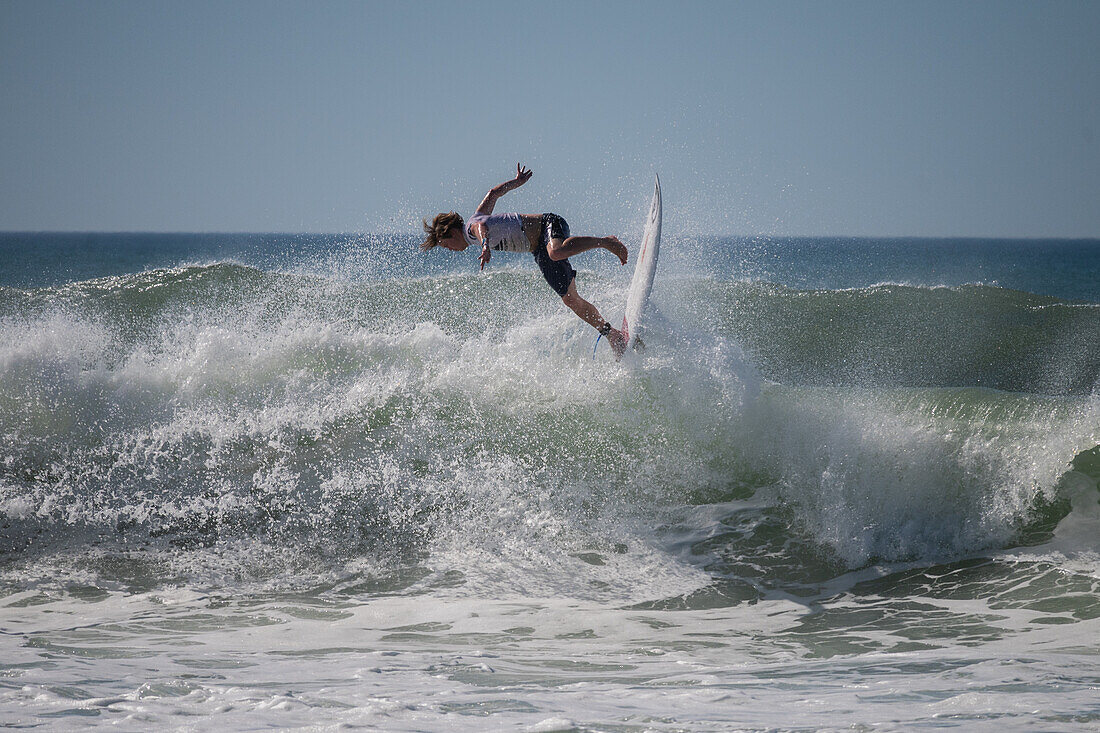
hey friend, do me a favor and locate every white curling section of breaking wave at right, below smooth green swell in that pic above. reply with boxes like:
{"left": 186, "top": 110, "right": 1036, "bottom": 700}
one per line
{"left": 748, "top": 386, "right": 1100, "bottom": 567}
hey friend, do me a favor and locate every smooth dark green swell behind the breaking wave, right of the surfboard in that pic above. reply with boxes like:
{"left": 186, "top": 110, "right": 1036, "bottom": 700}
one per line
{"left": 683, "top": 281, "right": 1100, "bottom": 395}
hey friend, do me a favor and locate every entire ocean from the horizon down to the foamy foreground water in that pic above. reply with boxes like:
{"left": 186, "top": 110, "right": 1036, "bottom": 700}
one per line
{"left": 0, "top": 230, "right": 1100, "bottom": 733}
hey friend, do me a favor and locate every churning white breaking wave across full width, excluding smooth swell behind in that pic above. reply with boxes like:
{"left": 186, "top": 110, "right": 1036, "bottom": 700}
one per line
{"left": 0, "top": 264, "right": 1097, "bottom": 592}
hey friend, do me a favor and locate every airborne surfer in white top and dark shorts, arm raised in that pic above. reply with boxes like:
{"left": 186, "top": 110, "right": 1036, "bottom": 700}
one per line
{"left": 420, "top": 165, "right": 627, "bottom": 357}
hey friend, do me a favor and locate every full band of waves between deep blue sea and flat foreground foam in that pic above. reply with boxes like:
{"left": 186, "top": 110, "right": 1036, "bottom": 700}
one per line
{"left": 0, "top": 263, "right": 1100, "bottom": 599}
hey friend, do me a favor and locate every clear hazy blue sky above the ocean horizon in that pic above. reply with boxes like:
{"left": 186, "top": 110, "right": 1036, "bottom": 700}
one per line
{"left": 0, "top": 0, "right": 1100, "bottom": 237}
